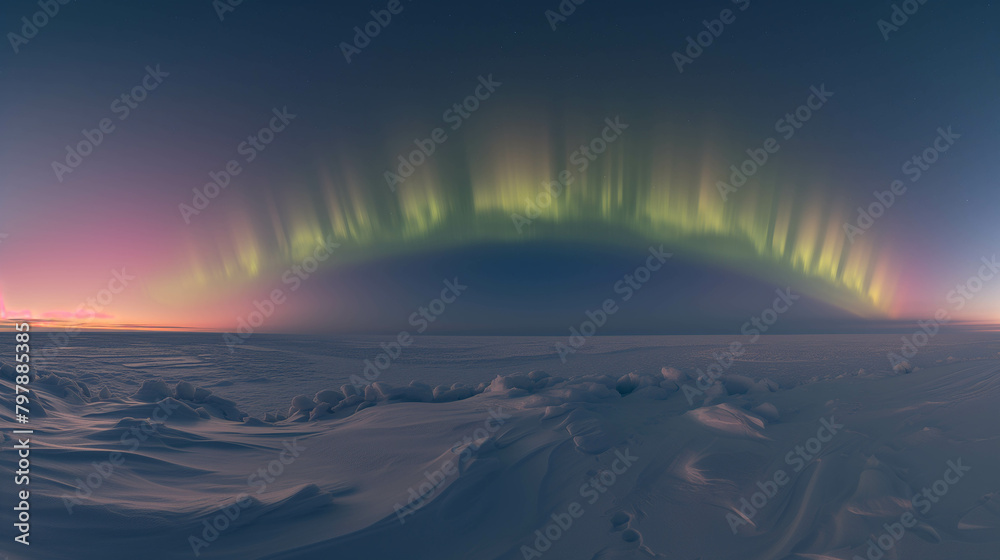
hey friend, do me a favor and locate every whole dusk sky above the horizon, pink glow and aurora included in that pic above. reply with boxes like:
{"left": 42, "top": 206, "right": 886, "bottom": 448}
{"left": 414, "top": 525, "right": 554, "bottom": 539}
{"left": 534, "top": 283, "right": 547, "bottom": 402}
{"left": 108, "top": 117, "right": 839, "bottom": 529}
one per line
{"left": 0, "top": 0, "right": 1000, "bottom": 334}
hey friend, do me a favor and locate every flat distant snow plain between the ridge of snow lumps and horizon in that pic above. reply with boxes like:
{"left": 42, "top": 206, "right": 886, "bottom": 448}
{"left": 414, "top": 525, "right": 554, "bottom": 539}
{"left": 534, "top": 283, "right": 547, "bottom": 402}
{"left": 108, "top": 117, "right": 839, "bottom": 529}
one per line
{"left": 23, "top": 333, "right": 1000, "bottom": 416}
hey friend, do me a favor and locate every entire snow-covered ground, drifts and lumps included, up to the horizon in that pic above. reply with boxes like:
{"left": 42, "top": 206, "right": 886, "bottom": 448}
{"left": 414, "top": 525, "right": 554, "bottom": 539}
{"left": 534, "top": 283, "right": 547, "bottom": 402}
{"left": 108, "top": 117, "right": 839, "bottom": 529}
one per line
{"left": 0, "top": 333, "right": 1000, "bottom": 560}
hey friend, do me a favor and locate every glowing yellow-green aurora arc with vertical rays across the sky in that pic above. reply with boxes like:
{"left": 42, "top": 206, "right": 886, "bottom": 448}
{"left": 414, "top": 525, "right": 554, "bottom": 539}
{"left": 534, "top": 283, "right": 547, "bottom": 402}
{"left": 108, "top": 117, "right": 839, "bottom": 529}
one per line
{"left": 158, "top": 116, "right": 894, "bottom": 317}
